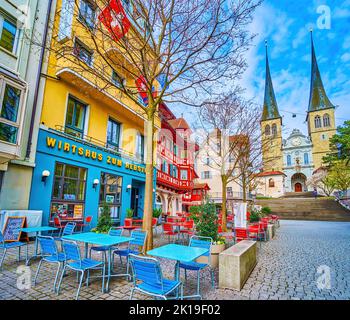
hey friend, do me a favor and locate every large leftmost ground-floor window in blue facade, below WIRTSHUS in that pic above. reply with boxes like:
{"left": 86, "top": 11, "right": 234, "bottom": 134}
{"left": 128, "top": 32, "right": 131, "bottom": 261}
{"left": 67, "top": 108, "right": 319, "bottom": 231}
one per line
{"left": 50, "top": 163, "right": 87, "bottom": 221}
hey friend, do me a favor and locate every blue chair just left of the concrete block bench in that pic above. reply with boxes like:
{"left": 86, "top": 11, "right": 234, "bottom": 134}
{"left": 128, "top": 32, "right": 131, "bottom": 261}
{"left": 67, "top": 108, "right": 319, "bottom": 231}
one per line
{"left": 179, "top": 236, "right": 214, "bottom": 299}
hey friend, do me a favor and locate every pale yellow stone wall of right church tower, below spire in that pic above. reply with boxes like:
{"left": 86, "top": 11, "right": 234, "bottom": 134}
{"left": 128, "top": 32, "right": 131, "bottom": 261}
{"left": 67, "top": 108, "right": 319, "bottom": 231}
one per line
{"left": 308, "top": 109, "right": 336, "bottom": 169}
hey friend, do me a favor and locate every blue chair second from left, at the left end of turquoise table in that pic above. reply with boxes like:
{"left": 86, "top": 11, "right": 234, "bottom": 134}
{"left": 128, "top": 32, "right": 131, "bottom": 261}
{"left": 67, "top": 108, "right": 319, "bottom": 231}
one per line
{"left": 34, "top": 236, "right": 66, "bottom": 292}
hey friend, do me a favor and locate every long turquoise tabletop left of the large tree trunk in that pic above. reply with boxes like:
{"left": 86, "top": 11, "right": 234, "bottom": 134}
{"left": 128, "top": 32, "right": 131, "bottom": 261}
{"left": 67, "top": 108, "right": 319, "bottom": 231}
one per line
{"left": 62, "top": 232, "right": 134, "bottom": 246}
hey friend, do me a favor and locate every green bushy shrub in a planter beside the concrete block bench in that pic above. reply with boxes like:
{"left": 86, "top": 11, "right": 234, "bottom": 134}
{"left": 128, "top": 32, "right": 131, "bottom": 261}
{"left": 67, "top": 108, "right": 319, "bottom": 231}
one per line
{"left": 190, "top": 200, "right": 226, "bottom": 268}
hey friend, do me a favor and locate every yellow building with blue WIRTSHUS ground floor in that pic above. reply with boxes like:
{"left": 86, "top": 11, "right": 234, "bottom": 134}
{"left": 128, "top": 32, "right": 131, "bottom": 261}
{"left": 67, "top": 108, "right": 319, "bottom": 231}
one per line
{"left": 30, "top": 0, "right": 160, "bottom": 225}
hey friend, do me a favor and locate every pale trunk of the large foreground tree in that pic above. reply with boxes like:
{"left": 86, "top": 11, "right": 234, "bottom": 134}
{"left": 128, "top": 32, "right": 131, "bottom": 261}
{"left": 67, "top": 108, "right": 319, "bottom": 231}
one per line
{"left": 143, "top": 113, "right": 154, "bottom": 252}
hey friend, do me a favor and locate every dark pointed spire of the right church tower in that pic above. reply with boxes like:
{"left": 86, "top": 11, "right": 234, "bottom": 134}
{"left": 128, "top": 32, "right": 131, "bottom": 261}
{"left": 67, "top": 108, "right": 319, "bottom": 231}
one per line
{"left": 308, "top": 30, "right": 334, "bottom": 112}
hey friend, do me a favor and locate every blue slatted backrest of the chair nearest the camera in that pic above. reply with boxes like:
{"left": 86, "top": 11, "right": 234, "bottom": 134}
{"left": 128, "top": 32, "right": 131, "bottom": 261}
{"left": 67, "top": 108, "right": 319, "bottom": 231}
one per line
{"left": 129, "top": 254, "right": 163, "bottom": 291}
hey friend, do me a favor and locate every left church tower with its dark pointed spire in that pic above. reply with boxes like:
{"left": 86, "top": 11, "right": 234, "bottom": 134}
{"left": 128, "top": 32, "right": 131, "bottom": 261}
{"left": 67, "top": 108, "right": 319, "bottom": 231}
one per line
{"left": 260, "top": 42, "right": 283, "bottom": 172}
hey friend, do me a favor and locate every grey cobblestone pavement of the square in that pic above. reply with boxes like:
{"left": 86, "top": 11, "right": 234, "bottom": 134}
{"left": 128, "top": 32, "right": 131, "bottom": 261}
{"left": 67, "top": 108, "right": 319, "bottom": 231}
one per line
{"left": 0, "top": 221, "right": 350, "bottom": 300}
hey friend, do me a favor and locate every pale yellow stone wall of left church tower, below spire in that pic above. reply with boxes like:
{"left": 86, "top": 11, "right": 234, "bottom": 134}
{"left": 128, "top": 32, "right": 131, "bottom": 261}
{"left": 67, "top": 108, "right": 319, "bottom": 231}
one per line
{"left": 261, "top": 118, "right": 283, "bottom": 172}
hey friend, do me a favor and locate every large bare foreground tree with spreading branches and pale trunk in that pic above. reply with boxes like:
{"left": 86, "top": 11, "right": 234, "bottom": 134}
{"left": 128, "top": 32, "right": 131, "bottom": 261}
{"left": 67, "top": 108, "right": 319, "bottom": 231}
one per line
{"left": 29, "top": 0, "right": 261, "bottom": 249}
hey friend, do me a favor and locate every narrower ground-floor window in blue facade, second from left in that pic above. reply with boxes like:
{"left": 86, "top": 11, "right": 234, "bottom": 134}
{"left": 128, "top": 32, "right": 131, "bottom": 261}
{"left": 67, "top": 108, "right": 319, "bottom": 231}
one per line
{"left": 100, "top": 172, "right": 123, "bottom": 220}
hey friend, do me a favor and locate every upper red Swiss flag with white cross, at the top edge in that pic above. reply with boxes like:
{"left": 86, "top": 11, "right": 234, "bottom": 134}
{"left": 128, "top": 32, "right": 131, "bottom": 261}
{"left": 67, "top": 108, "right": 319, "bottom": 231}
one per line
{"left": 98, "top": 0, "right": 130, "bottom": 41}
